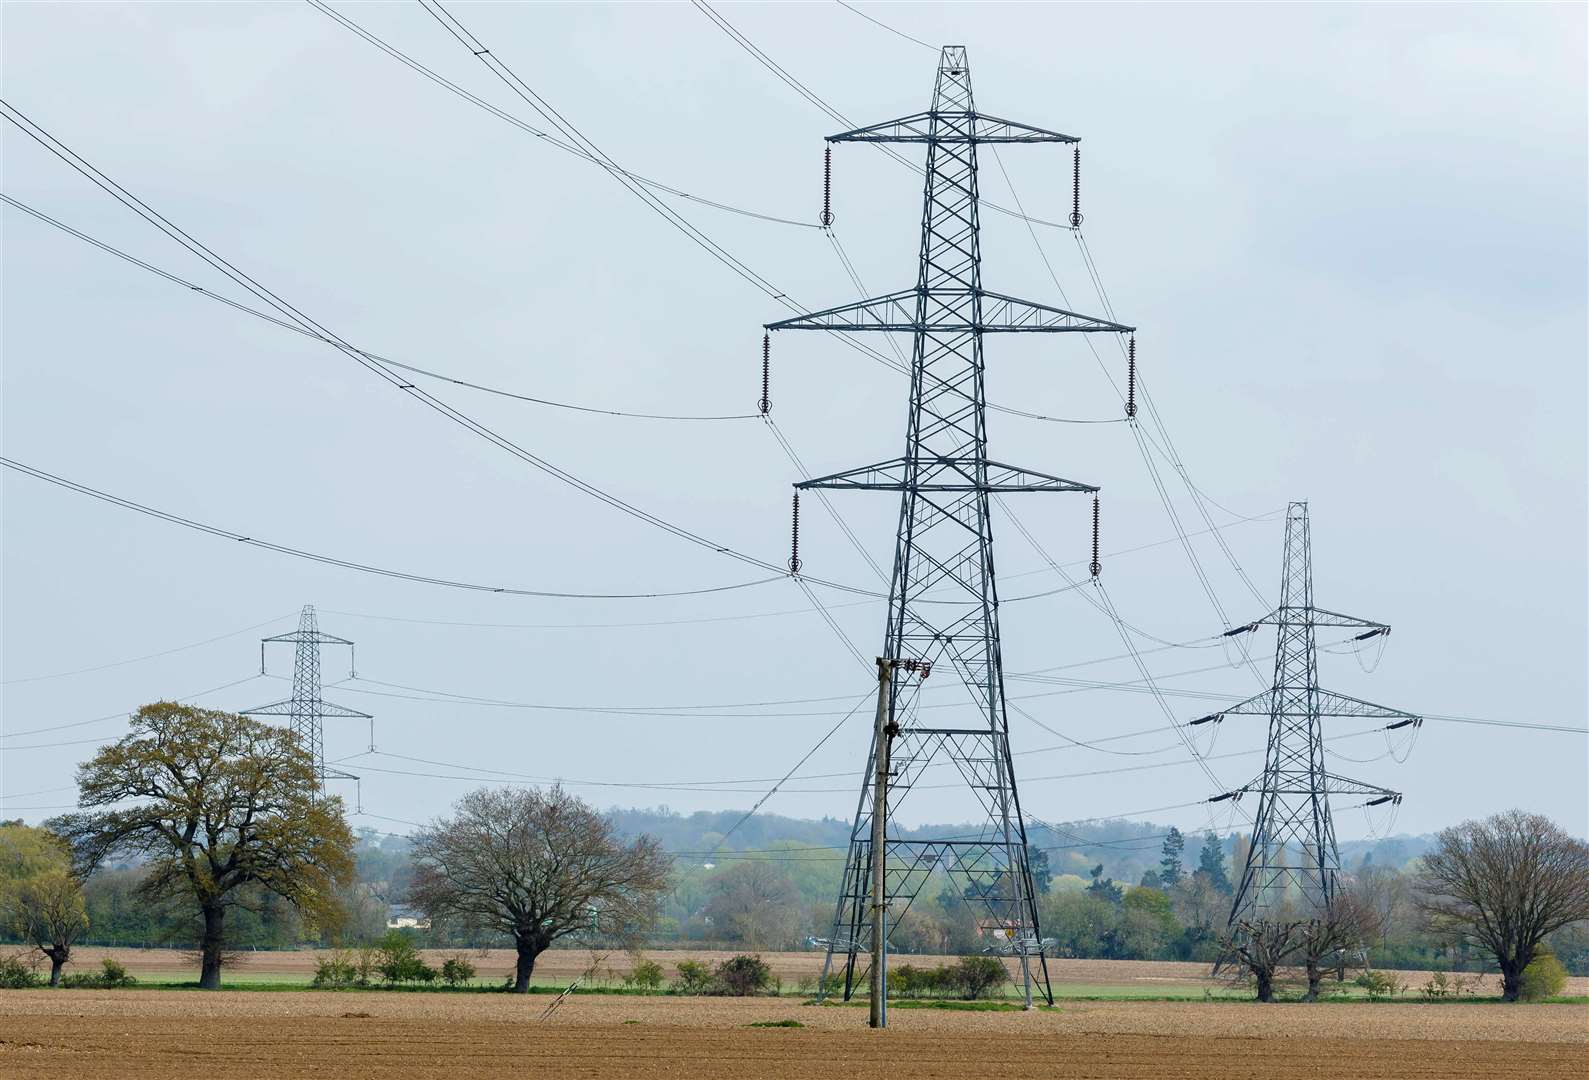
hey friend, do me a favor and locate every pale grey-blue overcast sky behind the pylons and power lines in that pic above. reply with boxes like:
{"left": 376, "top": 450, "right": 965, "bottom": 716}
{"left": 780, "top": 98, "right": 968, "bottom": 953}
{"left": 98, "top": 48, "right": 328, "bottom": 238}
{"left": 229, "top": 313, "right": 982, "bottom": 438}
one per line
{"left": 0, "top": 3, "right": 1589, "bottom": 839}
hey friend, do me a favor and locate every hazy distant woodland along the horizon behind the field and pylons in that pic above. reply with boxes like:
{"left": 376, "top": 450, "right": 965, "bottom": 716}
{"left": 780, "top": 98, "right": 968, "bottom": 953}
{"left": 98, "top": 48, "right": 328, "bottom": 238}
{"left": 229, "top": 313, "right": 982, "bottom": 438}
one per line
{"left": 21, "top": 808, "right": 1589, "bottom": 974}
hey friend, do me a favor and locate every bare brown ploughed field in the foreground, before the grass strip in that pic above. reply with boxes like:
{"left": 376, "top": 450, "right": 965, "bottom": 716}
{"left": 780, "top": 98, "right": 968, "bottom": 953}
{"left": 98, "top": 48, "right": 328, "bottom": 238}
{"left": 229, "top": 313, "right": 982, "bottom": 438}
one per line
{"left": 0, "top": 991, "right": 1589, "bottom": 1080}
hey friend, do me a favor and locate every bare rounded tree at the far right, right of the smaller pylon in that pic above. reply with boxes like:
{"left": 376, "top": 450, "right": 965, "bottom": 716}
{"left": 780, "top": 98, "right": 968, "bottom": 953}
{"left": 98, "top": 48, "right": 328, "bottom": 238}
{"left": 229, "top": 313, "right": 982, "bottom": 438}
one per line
{"left": 1417, "top": 810, "right": 1589, "bottom": 1001}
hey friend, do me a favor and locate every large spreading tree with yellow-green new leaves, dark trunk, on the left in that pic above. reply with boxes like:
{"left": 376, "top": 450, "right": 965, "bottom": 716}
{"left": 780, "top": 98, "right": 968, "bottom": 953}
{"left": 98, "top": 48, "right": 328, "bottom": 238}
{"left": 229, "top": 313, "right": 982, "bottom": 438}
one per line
{"left": 52, "top": 702, "right": 353, "bottom": 989}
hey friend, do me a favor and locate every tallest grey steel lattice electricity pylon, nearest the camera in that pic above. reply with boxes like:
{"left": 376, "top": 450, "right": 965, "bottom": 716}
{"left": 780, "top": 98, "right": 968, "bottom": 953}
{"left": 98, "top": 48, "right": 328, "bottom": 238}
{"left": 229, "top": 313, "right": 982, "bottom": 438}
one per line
{"left": 766, "top": 46, "right": 1131, "bottom": 1005}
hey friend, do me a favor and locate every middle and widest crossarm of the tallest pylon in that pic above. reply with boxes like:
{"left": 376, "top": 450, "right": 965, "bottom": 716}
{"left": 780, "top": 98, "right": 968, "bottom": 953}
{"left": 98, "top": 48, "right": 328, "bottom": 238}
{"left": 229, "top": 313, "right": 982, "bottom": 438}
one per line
{"left": 763, "top": 287, "right": 1136, "bottom": 334}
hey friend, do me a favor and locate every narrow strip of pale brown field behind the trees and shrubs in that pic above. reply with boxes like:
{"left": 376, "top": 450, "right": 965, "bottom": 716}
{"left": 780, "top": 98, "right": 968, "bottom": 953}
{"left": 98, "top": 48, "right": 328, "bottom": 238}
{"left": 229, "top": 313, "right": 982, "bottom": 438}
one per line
{"left": 61, "top": 948, "right": 1589, "bottom": 996}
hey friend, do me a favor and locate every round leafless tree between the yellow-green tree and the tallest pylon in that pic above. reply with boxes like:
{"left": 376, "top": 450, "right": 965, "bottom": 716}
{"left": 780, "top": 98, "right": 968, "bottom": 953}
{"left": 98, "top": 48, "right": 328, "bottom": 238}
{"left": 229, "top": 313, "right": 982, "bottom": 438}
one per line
{"left": 408, "top": 786, "right": 672, "bottom": 994}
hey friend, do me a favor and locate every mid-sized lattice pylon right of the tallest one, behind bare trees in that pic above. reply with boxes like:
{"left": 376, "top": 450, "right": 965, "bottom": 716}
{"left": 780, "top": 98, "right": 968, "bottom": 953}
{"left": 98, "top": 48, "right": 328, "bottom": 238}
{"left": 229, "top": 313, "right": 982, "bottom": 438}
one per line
{"left": 1192, "top": 502, "right": 1422, "bottom": 934}
